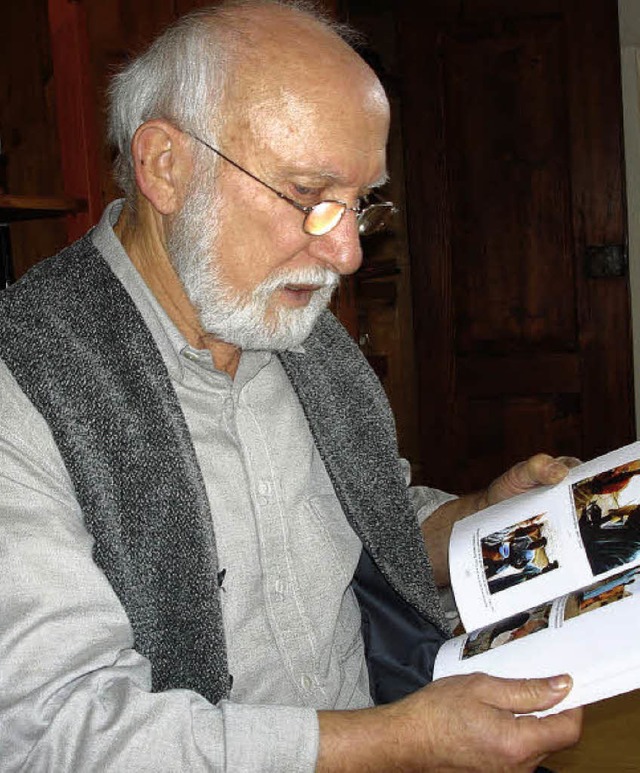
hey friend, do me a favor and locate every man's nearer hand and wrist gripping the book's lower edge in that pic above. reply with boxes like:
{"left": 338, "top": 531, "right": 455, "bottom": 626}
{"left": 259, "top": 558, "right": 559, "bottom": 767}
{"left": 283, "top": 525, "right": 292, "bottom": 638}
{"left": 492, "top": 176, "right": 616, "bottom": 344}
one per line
{"left": 317, "top": 674, "right": 582, "bottom": 773}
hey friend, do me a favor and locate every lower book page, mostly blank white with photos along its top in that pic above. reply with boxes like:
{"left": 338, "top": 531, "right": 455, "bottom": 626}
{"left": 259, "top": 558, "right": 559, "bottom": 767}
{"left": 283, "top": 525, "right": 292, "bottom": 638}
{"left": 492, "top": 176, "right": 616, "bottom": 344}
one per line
{"left": 434, "top": 567, "right": 640, "bottom": 713}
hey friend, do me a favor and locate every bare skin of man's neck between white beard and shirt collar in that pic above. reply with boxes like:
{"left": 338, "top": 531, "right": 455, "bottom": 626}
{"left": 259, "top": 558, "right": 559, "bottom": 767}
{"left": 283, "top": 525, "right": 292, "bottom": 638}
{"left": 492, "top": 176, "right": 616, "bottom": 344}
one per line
{"left": 113, "top": 205, "right": 242, "bottom": 378}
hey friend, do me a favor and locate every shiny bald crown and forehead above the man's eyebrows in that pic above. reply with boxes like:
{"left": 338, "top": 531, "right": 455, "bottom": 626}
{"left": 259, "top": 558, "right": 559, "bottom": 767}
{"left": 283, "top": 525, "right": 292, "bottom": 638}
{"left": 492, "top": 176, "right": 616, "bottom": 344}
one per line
{"left": 223, "top": 4, "right": 388, "bottom": 161}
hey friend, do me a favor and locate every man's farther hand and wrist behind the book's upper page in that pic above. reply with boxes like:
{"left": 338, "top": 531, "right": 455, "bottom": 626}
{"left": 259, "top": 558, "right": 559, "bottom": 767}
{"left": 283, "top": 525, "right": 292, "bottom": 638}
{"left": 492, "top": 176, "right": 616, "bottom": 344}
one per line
{"left": 422, "top": 454, "right": 580, "bottom": 585}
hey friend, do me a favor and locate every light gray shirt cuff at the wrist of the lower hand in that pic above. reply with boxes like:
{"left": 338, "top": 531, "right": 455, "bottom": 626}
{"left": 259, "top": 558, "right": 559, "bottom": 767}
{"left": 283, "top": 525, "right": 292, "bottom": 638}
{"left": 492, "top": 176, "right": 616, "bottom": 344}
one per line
{"left": 218, "top": 701, "right": 320, "bottom": 773}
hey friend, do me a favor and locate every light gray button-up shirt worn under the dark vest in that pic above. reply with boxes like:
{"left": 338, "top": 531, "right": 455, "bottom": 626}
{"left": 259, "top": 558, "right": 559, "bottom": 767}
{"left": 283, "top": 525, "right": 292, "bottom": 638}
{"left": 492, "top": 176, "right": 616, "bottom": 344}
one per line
{"left": 0, "top": 204, "right": 456, "bottom": 771}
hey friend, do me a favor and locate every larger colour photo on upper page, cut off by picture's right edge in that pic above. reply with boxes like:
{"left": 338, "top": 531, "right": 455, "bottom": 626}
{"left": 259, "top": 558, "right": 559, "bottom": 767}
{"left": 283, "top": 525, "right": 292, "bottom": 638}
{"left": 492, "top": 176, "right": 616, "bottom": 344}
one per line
{"left": 573, "top": 460, "right": 640, "bottom": 575}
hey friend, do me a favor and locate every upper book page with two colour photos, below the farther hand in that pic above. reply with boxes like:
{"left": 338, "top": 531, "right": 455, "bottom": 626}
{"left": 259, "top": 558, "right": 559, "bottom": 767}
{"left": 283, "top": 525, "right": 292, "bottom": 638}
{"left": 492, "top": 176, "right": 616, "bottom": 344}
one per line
{"left": 449, "top": 443, "right": 640, "bottom": 631}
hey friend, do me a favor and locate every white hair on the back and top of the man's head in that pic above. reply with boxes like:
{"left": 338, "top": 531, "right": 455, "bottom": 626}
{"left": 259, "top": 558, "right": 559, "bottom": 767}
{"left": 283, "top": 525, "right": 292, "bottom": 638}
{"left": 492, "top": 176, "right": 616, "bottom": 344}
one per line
{"left": 108, "top": 0, "right": 359, "bottom": 204}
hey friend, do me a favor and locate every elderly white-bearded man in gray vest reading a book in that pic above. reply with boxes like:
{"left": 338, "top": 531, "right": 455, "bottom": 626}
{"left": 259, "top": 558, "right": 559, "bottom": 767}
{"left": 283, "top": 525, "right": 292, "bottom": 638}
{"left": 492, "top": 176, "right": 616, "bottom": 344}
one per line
{"left": 0, "top": 2, "right": 580, "bottom": 772}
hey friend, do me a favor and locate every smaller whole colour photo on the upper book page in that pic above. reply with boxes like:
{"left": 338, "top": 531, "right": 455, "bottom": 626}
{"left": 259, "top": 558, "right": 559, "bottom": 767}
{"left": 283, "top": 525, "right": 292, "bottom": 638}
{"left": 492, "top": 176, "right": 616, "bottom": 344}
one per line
{"left": 480, "top": 513, "right": 558, "bottom": 594}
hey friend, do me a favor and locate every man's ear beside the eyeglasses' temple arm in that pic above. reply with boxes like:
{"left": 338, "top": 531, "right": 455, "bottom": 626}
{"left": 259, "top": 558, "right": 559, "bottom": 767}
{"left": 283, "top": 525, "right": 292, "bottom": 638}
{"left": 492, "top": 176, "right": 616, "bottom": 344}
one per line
{"left": 131, "top": 119, "right": 192, "bottom": 215}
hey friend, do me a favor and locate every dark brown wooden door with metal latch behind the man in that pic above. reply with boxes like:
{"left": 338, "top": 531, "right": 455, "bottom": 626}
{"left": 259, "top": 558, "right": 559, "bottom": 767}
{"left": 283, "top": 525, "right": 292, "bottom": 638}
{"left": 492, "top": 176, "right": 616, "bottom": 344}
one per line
{"left": 396, "top": 0, "right": 634, "bottom": 490}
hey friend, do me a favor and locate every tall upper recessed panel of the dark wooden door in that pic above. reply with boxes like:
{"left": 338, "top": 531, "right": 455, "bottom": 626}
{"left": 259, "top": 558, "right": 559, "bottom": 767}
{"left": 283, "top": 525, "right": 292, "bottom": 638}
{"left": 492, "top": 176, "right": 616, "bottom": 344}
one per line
{"left": 440, "top": 20, "right": 577, "bottom": 354}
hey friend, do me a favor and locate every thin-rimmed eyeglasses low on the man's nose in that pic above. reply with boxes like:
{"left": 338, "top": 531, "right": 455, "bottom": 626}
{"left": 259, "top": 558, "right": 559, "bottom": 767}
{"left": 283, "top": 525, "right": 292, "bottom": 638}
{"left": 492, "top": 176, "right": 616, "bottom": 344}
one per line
{"left": 183, "top": 130, "right": 397, "bottom": 236}
